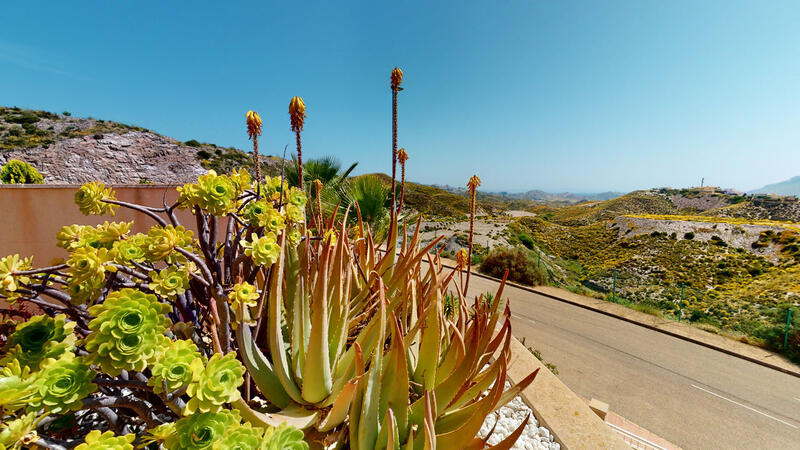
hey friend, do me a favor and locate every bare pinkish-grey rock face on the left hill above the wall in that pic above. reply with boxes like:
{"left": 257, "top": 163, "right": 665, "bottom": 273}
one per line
{"left": 0, "top": 131, "right": 206, "bottom": 184}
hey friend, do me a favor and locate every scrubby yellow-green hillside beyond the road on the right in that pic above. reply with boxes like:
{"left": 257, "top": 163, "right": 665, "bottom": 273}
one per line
{"left": 511, "top": 186, "right": 800, "bottom": 358}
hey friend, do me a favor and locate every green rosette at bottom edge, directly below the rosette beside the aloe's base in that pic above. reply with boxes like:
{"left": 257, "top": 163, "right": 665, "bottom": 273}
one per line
{"left": 164, "top": 410, "right": 241, "bottom": 450}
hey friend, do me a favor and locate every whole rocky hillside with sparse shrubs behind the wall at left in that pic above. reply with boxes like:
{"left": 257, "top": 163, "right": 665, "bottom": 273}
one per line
{"left": 0, "top": 107, "right": 275, "bottom": 184}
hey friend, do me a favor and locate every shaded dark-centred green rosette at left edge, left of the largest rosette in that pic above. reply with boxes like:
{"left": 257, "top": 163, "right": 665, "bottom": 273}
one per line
{"left": 0, "top": 314, "right": 77, "bottom": 370}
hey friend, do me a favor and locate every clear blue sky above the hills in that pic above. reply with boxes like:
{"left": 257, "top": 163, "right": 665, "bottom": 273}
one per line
{"left": 0, "top": 0, "right": 800, "bottom": 192}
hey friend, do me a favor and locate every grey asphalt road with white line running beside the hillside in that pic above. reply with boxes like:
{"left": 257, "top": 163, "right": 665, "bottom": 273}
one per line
{"left": 470, "top": 276, "right": 800, "bottom": 450}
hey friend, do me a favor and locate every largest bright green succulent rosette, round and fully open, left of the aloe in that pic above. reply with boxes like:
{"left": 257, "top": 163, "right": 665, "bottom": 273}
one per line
{"left": 85, "top": 288, "right": 171, "bottom": 376}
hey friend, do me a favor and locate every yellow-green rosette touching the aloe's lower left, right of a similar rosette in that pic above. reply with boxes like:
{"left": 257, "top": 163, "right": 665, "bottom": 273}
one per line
{"left": 183, "top": 352, "right": 245, "bottom": 415}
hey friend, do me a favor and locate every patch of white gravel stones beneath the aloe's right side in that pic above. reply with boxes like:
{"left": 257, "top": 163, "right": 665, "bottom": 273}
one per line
{"left": 478, "top": 383, "right": 561, "bottom": 450}
